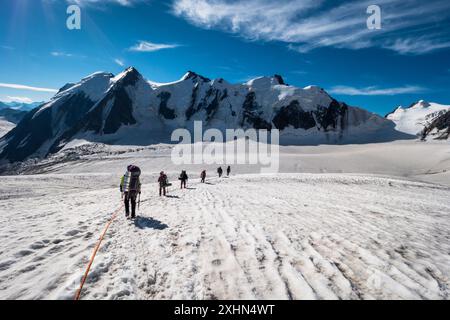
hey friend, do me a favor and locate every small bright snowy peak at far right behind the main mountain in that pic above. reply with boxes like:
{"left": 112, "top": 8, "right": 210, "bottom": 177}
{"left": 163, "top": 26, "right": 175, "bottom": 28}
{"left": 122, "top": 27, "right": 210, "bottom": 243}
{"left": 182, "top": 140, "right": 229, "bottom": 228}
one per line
{"left": 386, "top": 100, "right": 450, "bottom": 138}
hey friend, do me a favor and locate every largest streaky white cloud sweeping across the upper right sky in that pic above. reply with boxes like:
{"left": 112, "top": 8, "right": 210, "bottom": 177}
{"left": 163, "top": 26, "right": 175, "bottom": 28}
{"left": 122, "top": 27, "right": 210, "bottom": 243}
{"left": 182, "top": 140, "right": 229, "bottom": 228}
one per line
{"left": 172, "top": 0, "right": 450, "bottom": 54}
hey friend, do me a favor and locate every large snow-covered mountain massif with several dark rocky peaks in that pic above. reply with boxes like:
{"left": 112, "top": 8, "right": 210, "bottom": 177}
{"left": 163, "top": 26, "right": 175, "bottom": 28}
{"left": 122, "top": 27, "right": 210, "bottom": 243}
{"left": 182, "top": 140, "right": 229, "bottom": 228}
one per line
{"left": 0, "top": 67, "right": 409, "bottom": 162}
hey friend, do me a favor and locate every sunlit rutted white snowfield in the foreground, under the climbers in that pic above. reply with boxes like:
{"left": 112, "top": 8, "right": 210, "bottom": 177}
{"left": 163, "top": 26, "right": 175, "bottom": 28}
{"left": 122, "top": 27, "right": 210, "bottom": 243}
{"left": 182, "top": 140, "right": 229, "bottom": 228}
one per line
{"left": 0, "top": 174, "right": 450, "bottom": 299}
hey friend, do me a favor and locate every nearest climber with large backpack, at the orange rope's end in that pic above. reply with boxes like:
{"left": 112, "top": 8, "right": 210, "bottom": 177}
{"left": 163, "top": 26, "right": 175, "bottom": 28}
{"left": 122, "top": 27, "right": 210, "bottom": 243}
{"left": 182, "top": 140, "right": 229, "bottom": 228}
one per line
{"left": 120, "top": 165, "right": 141, "bottom": 219}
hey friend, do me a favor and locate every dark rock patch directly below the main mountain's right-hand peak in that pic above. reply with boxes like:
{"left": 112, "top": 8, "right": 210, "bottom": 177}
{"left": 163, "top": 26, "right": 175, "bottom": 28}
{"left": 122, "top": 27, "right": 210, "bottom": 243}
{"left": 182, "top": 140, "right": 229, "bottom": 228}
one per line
{"left": 272, "top": 100, "right": 316, "bottom": 130}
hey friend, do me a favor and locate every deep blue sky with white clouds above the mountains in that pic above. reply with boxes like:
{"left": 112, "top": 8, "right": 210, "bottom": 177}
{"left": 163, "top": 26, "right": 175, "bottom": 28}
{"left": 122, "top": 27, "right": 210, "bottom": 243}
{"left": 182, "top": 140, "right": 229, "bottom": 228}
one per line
{"left": 0, "top": 0, "right": 450, "bottom": 115}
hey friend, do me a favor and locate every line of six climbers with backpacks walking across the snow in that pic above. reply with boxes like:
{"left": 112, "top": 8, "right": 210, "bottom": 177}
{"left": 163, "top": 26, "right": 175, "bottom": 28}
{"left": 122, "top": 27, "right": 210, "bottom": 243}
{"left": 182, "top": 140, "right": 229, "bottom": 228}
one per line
{"left": 120, "top": 165, "right": 231, "bottom": 219}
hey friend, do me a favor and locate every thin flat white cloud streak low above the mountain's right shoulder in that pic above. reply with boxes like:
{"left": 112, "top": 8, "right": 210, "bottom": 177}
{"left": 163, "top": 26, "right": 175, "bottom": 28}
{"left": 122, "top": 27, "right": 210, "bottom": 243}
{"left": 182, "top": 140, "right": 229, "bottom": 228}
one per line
{"left": 328, "top": 86, "right": 427, "bottom": 96}
